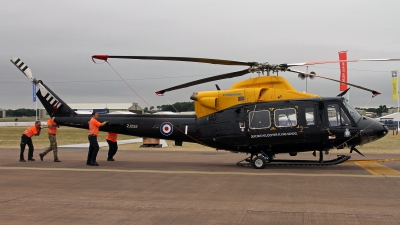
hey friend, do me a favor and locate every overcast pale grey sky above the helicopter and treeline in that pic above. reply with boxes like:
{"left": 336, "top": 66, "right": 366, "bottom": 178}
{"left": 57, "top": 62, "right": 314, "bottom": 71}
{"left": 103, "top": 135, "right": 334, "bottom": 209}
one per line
{"left": 0, "top": 0, "right": 400, "bottom": 109}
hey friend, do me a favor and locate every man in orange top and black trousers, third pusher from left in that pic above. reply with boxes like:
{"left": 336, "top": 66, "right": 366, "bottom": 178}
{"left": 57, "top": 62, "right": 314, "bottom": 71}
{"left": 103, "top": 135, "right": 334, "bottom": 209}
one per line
{"left": 86, "top": 112, "right": 107, "bottom": 166}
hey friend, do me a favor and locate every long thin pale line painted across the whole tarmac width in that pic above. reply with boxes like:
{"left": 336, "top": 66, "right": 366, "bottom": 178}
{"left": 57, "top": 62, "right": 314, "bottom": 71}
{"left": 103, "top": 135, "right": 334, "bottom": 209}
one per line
{"left": 0, "top": 166, "right": 400, "bottom": 178}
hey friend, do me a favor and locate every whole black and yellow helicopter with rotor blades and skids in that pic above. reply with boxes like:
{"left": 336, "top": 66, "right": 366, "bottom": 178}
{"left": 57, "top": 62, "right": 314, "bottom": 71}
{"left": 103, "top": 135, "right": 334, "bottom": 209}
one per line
{"left": 11, "top": 55, "right": 400, "bottom": 169}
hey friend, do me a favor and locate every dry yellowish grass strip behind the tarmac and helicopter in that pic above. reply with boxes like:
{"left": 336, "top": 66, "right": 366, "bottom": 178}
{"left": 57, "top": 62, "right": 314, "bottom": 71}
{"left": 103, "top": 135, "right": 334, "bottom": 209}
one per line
{"left": 0, "top": 127, "right": 400, "bottom": 154}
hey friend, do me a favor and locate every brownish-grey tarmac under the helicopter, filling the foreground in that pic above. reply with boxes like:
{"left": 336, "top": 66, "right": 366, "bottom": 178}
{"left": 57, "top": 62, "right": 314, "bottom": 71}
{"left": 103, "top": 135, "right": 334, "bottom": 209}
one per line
{"left": 0, "top": 148, "right": 400, "bottom": 224}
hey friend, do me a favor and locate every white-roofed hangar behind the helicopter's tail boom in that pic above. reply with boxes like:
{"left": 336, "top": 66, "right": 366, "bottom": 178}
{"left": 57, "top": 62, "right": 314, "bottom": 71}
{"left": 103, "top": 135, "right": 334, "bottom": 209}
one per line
{"left": 38, "top": 103, "right": 143, "bottom": 118}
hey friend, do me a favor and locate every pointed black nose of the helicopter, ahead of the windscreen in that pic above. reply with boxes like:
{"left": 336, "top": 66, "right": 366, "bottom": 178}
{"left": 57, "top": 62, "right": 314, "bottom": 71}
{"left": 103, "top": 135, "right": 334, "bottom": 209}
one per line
{"left": 359, "top": 117, "right": 389, "bottom": 144}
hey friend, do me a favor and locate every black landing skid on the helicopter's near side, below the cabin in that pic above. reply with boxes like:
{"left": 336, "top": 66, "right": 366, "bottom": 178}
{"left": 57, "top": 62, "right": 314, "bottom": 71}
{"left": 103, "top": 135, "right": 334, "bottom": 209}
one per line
{"left": 236, "top": 155, "right": 351, "bottom": 166}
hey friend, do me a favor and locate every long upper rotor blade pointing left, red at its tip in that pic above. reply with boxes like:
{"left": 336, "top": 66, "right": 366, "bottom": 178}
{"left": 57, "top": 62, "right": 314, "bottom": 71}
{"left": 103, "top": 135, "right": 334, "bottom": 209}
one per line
{"left": 92, "top": 55, "right": 253, "bottom": 66}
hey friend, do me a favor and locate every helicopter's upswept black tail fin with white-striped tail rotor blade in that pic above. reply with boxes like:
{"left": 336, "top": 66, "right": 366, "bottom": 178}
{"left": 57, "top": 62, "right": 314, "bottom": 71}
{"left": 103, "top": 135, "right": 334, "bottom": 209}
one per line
{"left": 11, "top": 57, "right": 76, "bottom": 116}
